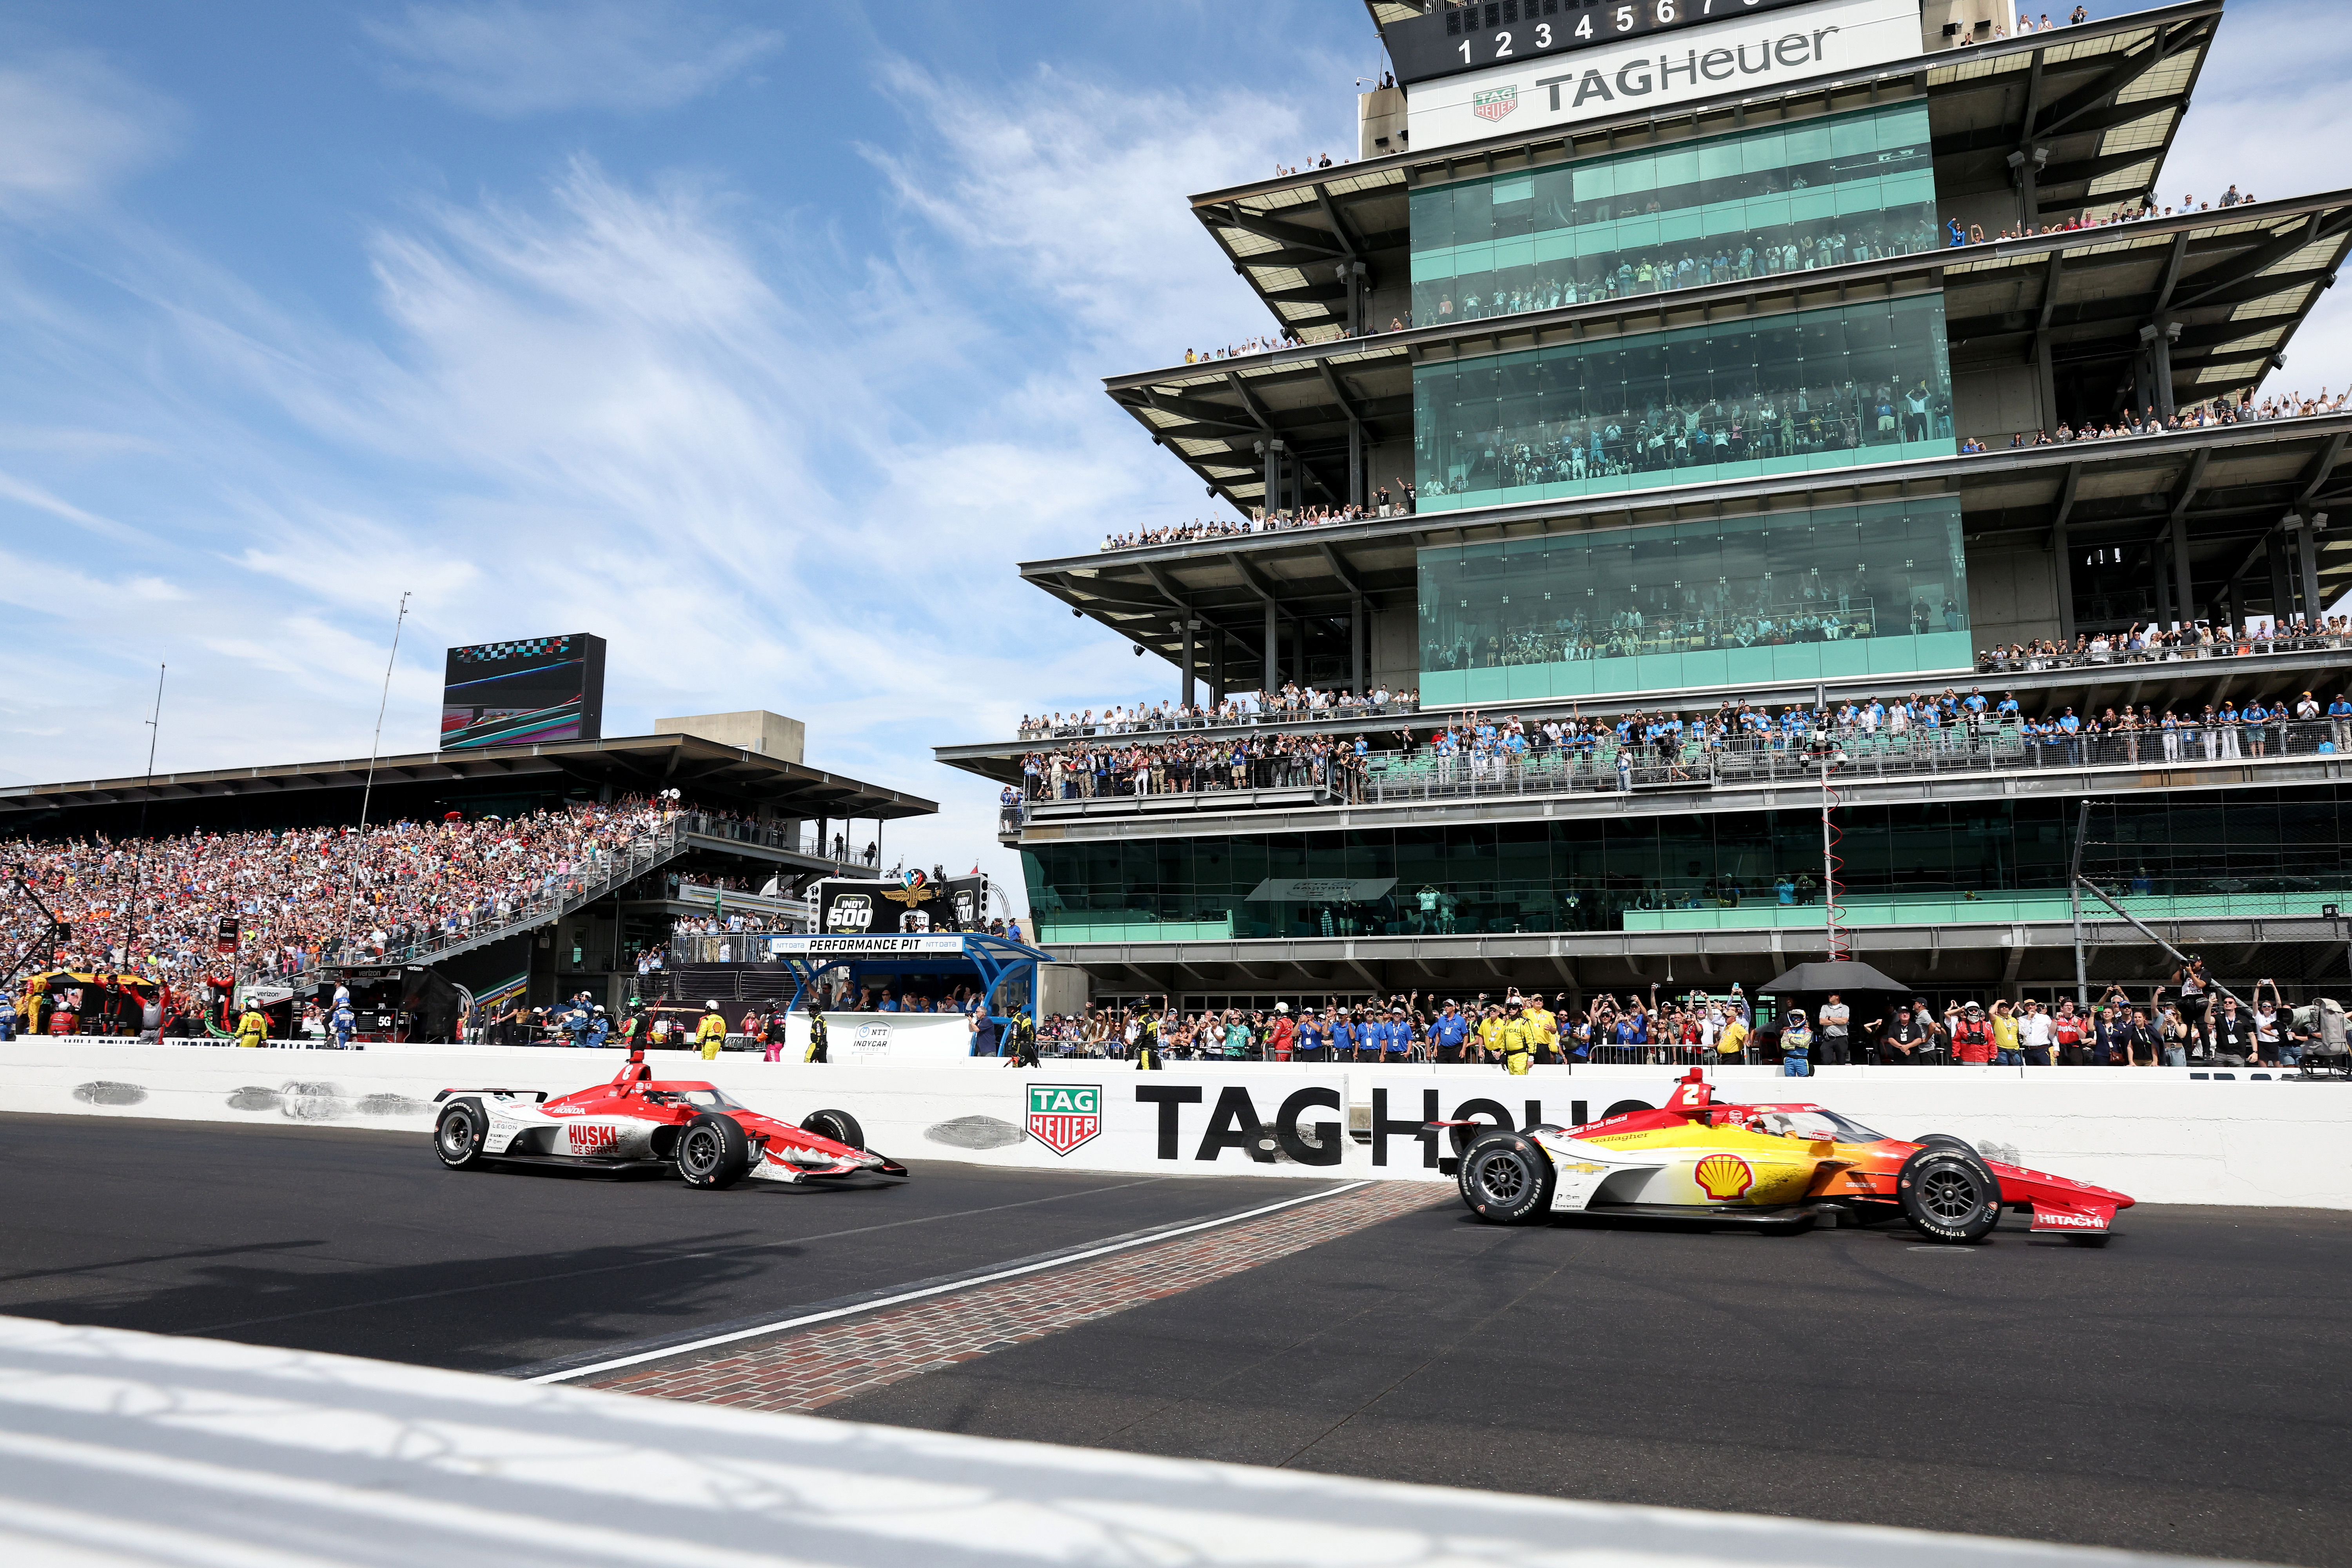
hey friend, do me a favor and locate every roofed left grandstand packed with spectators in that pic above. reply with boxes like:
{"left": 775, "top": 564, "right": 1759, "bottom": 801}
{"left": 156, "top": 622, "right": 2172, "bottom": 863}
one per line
{"left": 0, "top": 715, "right": 936, "bottom": 1013}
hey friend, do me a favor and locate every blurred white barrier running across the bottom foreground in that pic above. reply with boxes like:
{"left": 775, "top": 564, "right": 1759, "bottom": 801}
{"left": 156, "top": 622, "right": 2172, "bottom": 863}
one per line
{"left": 0, "top": 1319, "right": 2258, "bottom": 1568}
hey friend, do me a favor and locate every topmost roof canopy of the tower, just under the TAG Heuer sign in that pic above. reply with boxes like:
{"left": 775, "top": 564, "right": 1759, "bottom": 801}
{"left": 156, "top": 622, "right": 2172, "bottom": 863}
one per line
{"left": 1192, "top": 0, "right": 2223, "bottom": 343}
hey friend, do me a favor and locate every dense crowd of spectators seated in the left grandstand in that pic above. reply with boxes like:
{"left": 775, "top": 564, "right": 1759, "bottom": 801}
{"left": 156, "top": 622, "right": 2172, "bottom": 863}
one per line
{"left": 0, "top": 799, "right": 675, "bottom": 985}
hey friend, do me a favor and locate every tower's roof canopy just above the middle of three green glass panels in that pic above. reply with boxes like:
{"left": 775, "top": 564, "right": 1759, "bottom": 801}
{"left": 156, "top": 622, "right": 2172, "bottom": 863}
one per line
{"left": 1103, "top": 191, "right": 2352, "bottom": 510}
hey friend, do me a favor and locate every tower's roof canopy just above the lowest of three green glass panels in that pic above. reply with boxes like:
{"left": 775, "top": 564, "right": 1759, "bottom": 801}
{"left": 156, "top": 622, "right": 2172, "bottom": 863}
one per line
{"left": 1040, "top": 414, "right": 2352, "bottom": 668}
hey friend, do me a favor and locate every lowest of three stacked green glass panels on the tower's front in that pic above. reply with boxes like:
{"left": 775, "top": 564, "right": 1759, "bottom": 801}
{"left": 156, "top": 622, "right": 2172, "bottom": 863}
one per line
{"left": 1418, "top": 496, "right": 1973, "bottom": 708}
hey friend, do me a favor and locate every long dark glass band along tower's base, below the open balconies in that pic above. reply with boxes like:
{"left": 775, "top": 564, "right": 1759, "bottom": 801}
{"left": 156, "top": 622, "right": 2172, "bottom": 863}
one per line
{"left": 1021, "top": 785, "right": 2352, "bottom": 943}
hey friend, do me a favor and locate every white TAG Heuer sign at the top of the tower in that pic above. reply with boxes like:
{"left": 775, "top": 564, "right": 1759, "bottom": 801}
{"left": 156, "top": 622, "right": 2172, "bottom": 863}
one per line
{"left": 1404, "top": 0, "right": 1922, "bottom": 153}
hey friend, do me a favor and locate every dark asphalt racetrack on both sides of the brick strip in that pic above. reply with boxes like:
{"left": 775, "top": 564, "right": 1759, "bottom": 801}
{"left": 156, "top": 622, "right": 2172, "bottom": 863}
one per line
{"left": 0, "top": 1117, "right": 2352, "bottom": 1563}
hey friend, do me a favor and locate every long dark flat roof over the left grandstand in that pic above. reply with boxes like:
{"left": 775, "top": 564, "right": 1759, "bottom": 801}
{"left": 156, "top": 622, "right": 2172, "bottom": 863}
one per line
{"left": 0, "top": 736, "right": 938, "bottom": 830}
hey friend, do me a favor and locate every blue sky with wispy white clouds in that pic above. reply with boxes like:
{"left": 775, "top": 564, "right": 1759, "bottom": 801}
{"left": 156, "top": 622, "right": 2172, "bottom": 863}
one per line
{"left": 0, "top": 0, "right": 2352, "bottom": 907}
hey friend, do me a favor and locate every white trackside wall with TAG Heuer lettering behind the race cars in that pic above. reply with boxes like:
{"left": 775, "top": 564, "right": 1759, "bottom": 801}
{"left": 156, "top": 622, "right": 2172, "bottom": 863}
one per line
{"left": 0, "top": 1042, "right": 2352, "bottom": 1208}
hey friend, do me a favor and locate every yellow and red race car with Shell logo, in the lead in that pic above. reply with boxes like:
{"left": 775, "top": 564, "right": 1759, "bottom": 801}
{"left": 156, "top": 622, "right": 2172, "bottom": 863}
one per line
{"left": 1430, "top": 1067, "right": 2131, "bottom": 1246}
